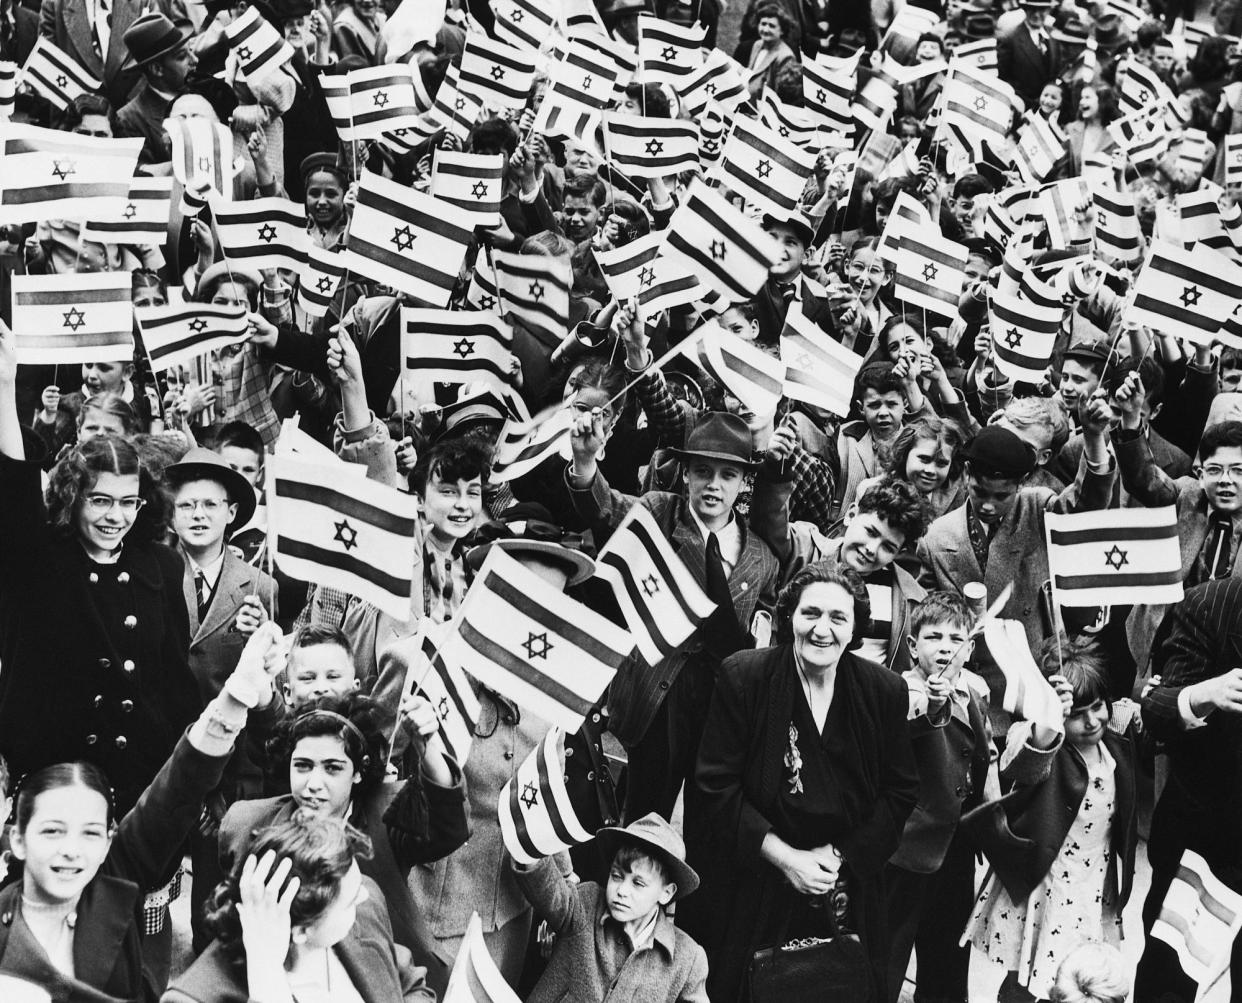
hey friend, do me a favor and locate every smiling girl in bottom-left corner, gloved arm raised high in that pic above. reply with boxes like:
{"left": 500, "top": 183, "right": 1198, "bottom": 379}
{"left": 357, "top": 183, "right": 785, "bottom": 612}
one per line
{"left": 0, "top": 627, "right": 282, "bottom": 1003}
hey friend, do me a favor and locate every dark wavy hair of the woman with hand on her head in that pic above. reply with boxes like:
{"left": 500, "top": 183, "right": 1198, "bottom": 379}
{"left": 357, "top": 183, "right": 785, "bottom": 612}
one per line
{"left": 204, "top": 809, "right": 371, "bottom": 961}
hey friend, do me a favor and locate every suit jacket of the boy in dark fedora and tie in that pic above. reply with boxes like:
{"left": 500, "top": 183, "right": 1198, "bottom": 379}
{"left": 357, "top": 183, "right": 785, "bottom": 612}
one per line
{"left": 566, "top": 473, "right": 780, "bottom": 745}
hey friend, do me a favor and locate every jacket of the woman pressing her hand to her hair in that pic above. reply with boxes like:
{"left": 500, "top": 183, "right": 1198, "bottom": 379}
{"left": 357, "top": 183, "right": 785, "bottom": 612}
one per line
{"left": 160, "top": 878, "right": 436, "bottom": 1003}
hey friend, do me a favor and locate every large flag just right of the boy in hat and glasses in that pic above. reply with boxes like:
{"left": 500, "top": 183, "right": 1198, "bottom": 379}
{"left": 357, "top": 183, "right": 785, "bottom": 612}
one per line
{"left": 266, "top": 453, "right": 422, "bottom": 622}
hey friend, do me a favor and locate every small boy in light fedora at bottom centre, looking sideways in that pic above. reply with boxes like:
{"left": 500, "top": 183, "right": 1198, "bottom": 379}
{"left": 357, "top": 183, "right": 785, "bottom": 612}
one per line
{"left": 513, "top": 813, "right": 707, "bottom": 1003}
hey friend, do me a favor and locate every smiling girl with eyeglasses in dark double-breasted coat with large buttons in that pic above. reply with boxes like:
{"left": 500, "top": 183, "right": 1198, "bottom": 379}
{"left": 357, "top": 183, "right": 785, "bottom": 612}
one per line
{"left": 0, "top": 325, "right": 202, "bottom": 812}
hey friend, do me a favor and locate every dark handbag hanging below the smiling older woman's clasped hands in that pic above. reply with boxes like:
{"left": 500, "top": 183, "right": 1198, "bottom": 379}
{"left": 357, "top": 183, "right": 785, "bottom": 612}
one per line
{"left": 749, "top": 884, "right": 876, "bottom": 1003}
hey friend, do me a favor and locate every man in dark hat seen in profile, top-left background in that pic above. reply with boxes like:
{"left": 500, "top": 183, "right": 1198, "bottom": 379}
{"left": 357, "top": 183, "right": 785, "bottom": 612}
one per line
{"left": 117, "top": 11, "right": 197, "bottom": 164}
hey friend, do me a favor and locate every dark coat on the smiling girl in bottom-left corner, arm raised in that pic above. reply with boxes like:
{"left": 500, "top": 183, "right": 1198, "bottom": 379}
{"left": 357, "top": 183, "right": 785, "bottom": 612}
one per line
{"left": 0, "top": 736, "right": 229, "bottom": 1003}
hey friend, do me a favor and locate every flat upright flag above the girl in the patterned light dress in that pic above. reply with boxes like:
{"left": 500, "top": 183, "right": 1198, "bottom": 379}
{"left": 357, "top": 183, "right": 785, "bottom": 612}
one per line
{"left": 1045, "top": 505, "right": 1184, "bottom": 606}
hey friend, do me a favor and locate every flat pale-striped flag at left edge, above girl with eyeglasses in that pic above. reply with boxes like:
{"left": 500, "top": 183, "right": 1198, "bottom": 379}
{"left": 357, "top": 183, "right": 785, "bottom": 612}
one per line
{"left": 10, "top": 272, "right": 134, "bottom": 365}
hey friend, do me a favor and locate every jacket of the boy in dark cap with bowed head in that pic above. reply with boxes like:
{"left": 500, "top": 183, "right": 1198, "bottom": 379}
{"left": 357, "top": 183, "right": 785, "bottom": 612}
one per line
{"left": 919, "top": 454, "right": 1117, "bottom": 648}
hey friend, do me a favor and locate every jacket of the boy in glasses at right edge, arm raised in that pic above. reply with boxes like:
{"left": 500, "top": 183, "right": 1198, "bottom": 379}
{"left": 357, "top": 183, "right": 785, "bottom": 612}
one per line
{"left": 1113, "top": 431, "right": 1242, "bottom": 672}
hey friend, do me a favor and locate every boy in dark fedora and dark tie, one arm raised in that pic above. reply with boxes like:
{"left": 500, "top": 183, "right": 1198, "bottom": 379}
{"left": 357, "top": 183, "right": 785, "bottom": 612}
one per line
{"left": 565, "top": 410, "right": 780, "bottom": 818}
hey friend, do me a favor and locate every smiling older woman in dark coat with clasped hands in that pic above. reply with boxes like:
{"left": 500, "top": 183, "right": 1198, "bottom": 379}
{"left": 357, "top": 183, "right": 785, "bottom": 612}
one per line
{"left": 677, "top": 566, "right": 919, "bottom": 1003}
